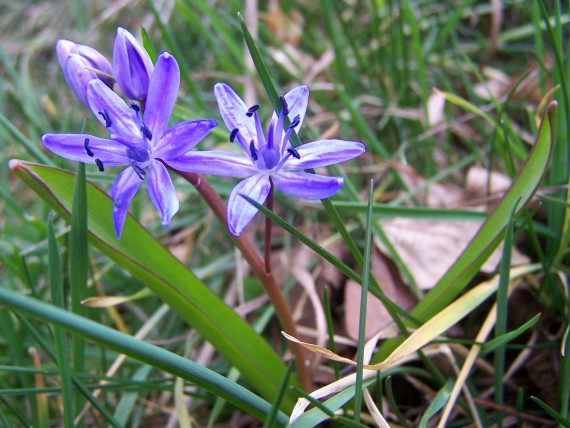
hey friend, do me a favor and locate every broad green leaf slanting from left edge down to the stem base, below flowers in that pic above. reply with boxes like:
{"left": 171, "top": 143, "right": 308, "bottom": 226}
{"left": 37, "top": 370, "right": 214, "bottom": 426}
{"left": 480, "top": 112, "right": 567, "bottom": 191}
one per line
{"left": 10, "top": 160, "right": 293, "bottom": 409}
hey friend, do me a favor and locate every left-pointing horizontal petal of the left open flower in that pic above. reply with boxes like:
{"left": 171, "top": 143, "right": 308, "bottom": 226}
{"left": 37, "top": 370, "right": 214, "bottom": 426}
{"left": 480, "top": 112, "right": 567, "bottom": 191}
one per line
{"left": 42, "top": 134, "right": 131, "bottom": 166}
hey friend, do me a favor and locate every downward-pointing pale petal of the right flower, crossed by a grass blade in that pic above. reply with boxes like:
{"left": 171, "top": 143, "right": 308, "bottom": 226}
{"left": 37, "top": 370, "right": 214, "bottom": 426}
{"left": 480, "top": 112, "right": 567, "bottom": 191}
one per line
{"left": 228, "top": 174, "right": 271, "bottom": 236}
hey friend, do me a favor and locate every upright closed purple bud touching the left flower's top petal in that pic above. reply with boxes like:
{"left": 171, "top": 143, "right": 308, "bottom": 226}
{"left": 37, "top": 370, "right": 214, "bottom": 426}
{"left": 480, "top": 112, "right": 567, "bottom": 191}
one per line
{"left": 113, "top": 27, "right": 154, "bottom": 102}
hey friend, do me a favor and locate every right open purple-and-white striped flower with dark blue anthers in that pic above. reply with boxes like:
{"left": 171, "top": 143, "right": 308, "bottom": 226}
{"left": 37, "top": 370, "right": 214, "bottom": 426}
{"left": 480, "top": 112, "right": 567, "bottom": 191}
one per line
{"left": 169, "top": 83, "right": 365, "bottom": 236}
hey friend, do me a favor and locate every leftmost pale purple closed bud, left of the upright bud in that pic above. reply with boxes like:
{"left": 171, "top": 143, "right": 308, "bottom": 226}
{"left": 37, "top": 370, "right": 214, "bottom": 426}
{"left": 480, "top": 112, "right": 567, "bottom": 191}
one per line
{"left": 55, "top": 39, "right": 113, "bottom": 106}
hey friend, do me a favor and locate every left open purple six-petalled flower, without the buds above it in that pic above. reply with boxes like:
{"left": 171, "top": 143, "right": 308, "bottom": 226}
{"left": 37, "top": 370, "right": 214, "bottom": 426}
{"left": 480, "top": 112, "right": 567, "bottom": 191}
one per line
{"left": 42, "top": 53, "right": 218, "bottom": 238}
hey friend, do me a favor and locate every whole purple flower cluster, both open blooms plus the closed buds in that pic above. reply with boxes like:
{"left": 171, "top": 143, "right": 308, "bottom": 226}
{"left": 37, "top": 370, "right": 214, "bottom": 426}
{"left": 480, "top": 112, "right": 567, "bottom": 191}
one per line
{"left": 42, "top": 28, "right": 365, "bottom": 238}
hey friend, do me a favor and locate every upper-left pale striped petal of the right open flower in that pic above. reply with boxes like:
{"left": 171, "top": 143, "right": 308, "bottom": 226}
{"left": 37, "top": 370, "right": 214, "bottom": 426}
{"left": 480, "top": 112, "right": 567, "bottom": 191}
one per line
{"left": 214, "top": 83, "right": 257, "bottom": 153}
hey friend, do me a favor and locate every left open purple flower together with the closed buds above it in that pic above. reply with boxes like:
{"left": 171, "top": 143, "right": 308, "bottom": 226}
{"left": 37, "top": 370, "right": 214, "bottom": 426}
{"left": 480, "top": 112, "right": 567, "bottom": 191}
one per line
{"left": 42, "top": 28, "right": 218, "bottom": 238}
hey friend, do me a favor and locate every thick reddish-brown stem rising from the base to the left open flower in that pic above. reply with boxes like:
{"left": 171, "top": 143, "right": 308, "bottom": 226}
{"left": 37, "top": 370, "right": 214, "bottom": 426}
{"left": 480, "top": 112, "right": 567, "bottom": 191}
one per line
{"left": 171, "top": 165, "right": 312, "bottom": 392}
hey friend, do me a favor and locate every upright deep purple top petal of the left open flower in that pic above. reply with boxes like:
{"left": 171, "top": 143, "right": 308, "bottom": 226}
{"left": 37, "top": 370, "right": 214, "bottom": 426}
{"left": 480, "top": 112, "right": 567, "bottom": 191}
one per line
{"left": 144, "top": 52, "right": 180, "bottom": 141}
